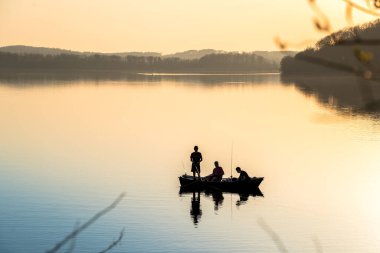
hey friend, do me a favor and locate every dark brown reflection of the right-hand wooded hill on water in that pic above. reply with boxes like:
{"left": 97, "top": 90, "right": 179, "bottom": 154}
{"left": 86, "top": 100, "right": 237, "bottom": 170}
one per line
{"left": 281, "top": 75, "right": 380, "bottom": 116}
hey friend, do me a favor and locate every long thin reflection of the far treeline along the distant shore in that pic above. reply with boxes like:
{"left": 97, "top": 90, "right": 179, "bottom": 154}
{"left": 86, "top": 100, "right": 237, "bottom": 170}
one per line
{"left": 0, "top": 70, "right": 279, "bottom": 87}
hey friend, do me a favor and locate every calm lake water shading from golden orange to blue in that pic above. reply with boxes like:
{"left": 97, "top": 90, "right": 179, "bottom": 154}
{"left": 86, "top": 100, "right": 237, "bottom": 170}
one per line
{"left": 0, "top": 74, "right": 380, "bottom": 253}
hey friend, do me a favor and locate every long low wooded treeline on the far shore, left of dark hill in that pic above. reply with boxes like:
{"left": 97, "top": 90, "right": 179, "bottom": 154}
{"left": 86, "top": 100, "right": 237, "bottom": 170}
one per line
{"left": 0, "top": 52, "right": 279, "bottom": 73}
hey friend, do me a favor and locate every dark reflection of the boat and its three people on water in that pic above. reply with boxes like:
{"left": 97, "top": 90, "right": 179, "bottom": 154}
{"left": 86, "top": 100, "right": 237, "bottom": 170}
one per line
{"left": 179, "top": 187, "right": 264, "bottom": 225}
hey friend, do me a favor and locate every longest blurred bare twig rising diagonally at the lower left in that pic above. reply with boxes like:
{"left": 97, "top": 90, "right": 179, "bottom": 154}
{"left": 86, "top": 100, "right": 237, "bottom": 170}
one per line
{"left": 46, "top": 193, "right": 125, "bottom": 253}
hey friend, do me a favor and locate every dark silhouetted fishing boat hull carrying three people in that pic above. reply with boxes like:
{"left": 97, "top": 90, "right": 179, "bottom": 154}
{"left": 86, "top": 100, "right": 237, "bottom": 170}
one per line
{"left": 179, "top": 174, "right": 264, "bottom": 193}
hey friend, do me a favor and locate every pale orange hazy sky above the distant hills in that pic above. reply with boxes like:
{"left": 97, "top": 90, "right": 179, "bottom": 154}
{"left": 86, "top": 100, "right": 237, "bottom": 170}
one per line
{"left": 0, "top": 0, "right": 373, "bottom": 53}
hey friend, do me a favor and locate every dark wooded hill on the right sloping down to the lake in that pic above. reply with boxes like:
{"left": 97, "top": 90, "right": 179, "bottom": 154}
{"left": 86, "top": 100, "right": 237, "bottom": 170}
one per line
{"left": 281, "top": 19, "right": 380, "bottom": 75}
